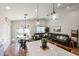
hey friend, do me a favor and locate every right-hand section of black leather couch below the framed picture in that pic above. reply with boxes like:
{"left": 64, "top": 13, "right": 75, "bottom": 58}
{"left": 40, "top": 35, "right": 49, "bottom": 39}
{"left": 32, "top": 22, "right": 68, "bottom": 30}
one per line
{"left": 48, "top": 33, "right": 71, "bottom": 46}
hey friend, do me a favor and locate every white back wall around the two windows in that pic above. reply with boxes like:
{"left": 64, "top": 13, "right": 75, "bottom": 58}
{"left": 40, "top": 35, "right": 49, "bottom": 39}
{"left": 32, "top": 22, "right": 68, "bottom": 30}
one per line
{"left": 11, "top": 20, "right": 48, "bottom": 39}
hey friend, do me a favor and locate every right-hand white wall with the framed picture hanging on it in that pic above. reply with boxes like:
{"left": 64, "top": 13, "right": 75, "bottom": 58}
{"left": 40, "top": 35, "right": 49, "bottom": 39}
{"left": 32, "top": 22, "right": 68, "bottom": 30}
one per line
{"left": 49, "top": 9, "right": 79, "bottom": 46}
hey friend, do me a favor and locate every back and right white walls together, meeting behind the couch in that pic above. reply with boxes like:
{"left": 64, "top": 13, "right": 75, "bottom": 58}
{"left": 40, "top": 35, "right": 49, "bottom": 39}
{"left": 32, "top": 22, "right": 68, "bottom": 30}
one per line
{"left": 12, "top": 8, "right": 79, "bottom": 46}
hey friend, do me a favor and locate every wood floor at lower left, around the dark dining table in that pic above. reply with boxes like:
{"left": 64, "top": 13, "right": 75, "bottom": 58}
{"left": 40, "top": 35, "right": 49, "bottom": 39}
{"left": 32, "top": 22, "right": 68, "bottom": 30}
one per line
{"left": 4, "top": 42, "right": 27, "bottom": 56}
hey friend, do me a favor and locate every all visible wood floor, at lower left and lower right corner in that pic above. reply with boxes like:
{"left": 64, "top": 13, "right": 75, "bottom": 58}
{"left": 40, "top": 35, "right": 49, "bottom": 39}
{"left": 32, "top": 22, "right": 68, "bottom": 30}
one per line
{"left": 4, "top": 42, "right": 79, "bottom": 56}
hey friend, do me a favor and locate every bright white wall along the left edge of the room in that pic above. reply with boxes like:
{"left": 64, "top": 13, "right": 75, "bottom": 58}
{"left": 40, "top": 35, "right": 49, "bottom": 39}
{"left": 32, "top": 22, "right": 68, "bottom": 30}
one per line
{"left": 0, "top": 17, "right": 11, "bottom": 50}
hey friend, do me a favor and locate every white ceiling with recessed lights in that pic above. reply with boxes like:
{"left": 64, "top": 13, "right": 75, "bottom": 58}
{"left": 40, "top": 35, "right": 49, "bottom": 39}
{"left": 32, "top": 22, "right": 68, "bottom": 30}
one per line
{"left": 0, "top": 3, "right": 79, "bottom": 20}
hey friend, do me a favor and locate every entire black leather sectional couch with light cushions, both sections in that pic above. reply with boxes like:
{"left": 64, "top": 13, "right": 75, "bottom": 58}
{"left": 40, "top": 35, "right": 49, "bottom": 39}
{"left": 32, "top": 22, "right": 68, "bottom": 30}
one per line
{"left": 33, "top": 33, "right": 71, "bottom": 46}
